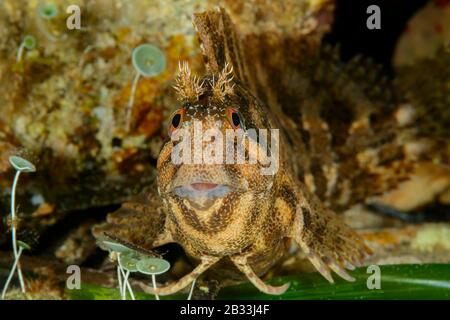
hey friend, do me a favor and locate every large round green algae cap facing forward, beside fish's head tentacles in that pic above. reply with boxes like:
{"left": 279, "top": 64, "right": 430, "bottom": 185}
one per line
{"left": 131, "top": 43, "right": 166, "bottom": 77}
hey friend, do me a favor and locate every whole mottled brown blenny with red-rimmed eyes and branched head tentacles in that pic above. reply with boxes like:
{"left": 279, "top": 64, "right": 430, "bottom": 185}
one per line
{"left": 94, "top": 10, "right": 450, "bottom": 295}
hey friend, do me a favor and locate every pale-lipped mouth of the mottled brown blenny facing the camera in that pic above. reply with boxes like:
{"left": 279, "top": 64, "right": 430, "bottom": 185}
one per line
{"left": 173, "top": 182, "right": 233, "bottom": 209}
